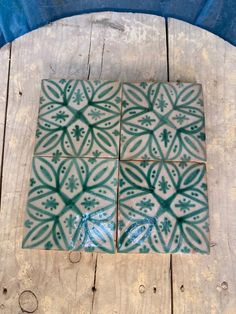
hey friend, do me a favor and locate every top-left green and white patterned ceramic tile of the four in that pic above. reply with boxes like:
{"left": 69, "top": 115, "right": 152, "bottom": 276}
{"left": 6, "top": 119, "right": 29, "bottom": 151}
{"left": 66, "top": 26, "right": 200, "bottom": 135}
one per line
{"left": 35, "top": 79, "right": 121, "bottom": 157}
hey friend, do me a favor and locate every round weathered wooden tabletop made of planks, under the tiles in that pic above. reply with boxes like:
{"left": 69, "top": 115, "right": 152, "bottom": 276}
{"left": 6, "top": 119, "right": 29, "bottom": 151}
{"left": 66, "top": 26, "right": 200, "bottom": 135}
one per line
{"left": 0, "top": 13, "right": 236, "bottom": 314}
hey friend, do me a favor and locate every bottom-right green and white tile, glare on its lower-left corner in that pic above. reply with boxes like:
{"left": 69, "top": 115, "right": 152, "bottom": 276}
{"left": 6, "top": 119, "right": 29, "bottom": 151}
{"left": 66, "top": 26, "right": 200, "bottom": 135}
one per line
{"left": 118, "top": 161, "right": 209, "bottom": 253}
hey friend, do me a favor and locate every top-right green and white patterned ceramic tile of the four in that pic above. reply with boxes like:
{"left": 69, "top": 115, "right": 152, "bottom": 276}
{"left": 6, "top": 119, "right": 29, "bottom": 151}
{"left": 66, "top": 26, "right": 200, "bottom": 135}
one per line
{"left": 121, "top": 82, "right": 205, "bottom": 161}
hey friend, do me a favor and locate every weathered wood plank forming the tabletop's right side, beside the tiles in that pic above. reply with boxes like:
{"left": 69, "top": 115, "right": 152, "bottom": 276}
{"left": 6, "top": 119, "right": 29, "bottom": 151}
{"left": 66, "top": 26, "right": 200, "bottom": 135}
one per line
{"left": 169, "top": 19, "right": 236, "bottom": 314}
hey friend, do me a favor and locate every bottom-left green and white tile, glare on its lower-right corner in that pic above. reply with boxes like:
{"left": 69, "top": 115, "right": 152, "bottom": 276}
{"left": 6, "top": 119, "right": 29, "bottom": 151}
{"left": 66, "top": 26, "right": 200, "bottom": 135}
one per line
{"left": 23, "top": 157, "right": 118, "bottom": 253}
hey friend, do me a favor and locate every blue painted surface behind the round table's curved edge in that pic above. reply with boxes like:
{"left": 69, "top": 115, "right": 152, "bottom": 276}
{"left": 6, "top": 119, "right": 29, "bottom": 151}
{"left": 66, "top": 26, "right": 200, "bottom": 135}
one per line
{"left": 0, "top": 0, "right": 236, "bottom": 47}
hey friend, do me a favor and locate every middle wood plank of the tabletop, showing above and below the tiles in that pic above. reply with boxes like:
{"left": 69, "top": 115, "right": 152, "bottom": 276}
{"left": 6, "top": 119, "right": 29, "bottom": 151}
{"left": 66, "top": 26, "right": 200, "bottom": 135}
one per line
{"left": 90, "top": 13, "right": 171, "bottom": 314}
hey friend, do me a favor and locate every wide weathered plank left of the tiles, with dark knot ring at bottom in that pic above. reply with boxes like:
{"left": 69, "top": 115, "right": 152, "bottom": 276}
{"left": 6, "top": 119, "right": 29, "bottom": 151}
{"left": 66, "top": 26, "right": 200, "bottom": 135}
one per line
{"left": 0, "top": 15, "right": 95, "bottom": 314}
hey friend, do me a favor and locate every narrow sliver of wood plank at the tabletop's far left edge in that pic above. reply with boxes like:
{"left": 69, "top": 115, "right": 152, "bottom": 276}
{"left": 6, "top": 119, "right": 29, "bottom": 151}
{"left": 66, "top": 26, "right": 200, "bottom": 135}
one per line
{"left": 0, "top": 45, "right": 10, "bottom": 177}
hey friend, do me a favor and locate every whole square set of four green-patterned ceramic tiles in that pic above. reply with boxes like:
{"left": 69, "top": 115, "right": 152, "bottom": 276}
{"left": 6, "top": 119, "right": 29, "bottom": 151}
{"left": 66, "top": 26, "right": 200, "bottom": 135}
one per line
{"left": 23, "top": 79, "right": 209, "bottom": 253}
